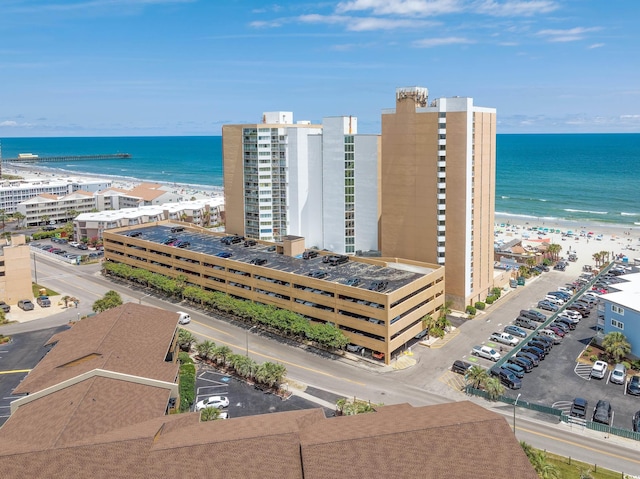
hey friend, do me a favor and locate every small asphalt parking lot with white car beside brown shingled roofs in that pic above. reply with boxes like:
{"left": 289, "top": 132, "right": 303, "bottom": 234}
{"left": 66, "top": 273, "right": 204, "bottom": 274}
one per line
{"left": 194, "top": 363, "right": 340, "bottom": 418}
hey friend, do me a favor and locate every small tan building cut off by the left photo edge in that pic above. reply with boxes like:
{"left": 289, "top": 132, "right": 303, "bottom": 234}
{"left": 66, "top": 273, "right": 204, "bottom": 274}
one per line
{"left": 0, "top": 235, "right": 33, "bottom": 305}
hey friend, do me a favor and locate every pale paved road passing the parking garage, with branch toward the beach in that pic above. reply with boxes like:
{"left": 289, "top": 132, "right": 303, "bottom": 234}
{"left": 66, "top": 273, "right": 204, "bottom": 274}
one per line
{"left": 2, "top": 261, "right": 640, "bottom": 475}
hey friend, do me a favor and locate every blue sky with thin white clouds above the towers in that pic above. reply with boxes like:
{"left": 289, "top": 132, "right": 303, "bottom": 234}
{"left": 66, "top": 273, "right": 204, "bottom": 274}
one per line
{"left": 0, "top": 0, "right": 640, "bottom": 138}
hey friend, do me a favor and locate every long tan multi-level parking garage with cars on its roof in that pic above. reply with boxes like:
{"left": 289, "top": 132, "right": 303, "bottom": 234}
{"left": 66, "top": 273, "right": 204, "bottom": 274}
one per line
{"left": 103, "top": 222, "right": 444, "bottom": 364}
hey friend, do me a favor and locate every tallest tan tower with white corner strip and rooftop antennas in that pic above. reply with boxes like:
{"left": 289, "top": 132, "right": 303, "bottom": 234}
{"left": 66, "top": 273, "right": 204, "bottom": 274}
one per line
{"left": 380, "top": 87, "right": 496, "bottom": 309}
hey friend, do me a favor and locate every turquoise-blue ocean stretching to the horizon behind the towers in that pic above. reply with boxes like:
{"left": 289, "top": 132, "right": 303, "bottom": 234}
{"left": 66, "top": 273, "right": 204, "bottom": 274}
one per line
{"left": 0, "top": 134, "right": 640, "bottom": 226}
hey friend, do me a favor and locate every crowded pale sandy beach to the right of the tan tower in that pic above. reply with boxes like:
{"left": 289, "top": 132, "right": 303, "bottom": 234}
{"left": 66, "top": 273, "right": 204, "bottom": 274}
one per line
{"left": 494, "top": 214, "right": 640, "bottom": 265}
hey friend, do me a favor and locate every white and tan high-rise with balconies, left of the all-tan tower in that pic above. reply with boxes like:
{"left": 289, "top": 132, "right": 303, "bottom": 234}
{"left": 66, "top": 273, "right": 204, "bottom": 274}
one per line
{"left": 222, "top": 111, "right": 380, "bottom": 254}
